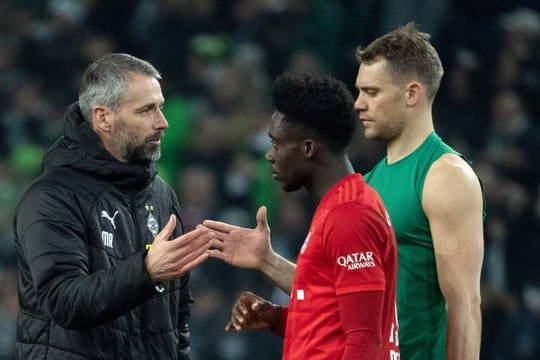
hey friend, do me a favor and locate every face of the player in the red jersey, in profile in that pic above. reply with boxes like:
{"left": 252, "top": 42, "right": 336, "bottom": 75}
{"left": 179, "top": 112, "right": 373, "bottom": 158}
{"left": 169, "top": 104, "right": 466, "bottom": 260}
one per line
{"left": 265, "top": 111, "right": 306, "bottom": 192}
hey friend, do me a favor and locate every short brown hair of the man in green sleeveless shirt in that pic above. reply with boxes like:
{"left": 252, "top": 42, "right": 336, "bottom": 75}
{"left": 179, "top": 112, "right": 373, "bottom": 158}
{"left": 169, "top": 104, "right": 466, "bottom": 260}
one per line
{"left": 356, "top": 22, "right": 444, "bottom": 101}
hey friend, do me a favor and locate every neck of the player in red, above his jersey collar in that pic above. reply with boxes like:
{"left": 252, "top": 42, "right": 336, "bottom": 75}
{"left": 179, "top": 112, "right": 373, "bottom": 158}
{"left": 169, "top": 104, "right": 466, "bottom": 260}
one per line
{"left": 306, "top": 154, "right": 354, "bottom": 202}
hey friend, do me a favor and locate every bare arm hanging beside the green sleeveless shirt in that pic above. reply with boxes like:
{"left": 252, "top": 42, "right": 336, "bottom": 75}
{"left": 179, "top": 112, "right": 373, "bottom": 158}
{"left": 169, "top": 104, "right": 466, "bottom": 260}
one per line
{"left": 423, "top": 154, "right": 484, "bottom": 360}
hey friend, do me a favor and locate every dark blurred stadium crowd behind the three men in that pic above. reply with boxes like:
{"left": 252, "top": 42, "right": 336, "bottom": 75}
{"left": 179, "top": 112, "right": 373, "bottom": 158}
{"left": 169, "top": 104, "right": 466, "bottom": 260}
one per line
{"left": 0, "top": 0, "right": 540, "bottom": 360}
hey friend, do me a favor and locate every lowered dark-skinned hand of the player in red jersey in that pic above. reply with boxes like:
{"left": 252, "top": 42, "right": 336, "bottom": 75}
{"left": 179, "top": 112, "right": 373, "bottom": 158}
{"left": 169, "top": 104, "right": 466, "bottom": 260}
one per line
{"left": 225, "top": 291, "right": 281, "bottom": 331}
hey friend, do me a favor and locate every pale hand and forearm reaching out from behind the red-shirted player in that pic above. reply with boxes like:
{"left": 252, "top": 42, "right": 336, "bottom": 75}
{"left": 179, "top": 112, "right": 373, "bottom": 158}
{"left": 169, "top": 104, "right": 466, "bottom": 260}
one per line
{"left": 203, "top": 206, "right": 296, "bottom": 294}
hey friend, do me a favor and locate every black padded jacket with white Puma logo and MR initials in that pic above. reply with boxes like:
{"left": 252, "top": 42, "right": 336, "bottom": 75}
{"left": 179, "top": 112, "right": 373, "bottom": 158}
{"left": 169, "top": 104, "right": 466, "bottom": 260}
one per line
{"left": 14, "top": 104, "right": 192, "bottom": 360}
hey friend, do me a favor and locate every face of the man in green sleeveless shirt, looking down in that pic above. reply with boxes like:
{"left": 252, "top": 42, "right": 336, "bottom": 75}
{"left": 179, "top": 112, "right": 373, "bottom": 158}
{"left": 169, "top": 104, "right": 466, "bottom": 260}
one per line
{"left": 354, "top": 59, "right": 406, "bottom": 142}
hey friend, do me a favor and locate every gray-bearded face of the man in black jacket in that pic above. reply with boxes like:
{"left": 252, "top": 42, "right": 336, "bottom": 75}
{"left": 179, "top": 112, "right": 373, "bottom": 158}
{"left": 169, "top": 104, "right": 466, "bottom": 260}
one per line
{"left": 111, "top": 74, "right": 169, "bottom": 163}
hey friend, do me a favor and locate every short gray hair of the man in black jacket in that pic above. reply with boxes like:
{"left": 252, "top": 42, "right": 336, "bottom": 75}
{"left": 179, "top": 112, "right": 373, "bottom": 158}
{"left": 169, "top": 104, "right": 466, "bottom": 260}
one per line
{"left": 79, "top": 53, "right": 161, "bottom": 122}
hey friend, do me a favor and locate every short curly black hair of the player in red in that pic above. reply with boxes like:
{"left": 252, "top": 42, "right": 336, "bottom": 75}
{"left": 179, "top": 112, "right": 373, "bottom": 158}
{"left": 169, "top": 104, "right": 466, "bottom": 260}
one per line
{"left": 272, "top": 71, "right": 358, "bottom": 152}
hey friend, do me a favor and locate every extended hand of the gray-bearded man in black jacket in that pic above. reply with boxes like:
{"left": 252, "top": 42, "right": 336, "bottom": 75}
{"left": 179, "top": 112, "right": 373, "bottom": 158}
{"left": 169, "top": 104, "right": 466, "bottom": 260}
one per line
{"left": 145, "top": 215, "right": 214, "bottom": 282}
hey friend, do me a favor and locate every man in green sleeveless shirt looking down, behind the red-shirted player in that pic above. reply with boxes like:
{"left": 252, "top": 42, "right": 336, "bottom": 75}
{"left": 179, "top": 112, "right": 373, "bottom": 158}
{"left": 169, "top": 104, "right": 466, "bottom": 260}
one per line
{"left": 355, "top": 23, "right": 483, "bottom": 360}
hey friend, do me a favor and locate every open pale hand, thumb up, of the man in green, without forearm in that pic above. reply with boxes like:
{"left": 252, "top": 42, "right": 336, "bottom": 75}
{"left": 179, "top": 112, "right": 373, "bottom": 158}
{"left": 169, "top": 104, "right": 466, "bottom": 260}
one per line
{"left": 203, "top": 206, "right": 273, "bottom": 270}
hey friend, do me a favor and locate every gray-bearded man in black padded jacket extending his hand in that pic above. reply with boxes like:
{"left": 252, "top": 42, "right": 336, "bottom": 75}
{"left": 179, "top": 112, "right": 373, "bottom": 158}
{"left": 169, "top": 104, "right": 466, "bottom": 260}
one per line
{"left": 14, "top": 54, "right": 211, "bottom": 359}
